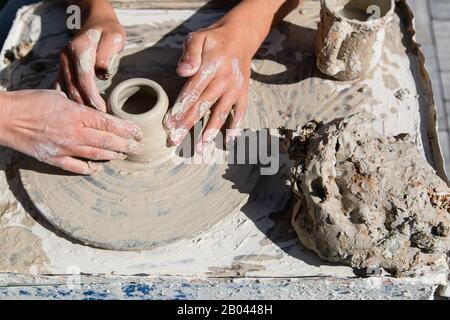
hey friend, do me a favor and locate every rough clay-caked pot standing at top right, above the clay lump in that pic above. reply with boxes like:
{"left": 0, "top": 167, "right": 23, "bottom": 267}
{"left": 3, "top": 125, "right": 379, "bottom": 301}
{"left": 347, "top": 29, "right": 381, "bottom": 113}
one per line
{"left": 315, "top": 0, "right": 395, "bottom": 80}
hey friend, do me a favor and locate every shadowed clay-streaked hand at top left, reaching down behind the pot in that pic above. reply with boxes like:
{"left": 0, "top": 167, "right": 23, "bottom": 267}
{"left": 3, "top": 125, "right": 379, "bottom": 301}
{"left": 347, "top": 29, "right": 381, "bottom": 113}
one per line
{"left": 56, "top": 0, "right": 126, "bottom": 112}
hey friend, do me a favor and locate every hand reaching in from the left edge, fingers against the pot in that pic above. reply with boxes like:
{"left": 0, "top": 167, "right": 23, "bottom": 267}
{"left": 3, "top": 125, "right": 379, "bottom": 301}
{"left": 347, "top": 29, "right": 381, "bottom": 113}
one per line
{"left": 0, "top": 90, "right": 142, "bottom": 175}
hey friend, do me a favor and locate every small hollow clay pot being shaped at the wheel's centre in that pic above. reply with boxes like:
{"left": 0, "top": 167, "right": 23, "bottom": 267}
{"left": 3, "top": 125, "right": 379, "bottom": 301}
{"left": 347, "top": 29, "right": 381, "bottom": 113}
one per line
{"left": 108, "top": 78, "right": 169, "bottom": 162}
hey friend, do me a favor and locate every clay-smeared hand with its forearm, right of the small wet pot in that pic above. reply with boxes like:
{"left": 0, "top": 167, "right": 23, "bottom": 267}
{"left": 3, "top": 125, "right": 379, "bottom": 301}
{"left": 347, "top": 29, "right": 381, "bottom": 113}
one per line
{"left": 165, "top": 0, "right": 301, "bottom": 153}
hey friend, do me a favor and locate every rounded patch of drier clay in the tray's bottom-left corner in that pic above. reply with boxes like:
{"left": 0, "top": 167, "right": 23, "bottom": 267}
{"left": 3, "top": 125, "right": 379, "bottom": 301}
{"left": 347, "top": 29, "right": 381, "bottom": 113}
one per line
{"left": 0, "top": 227, "right": 49, "bottom": 273}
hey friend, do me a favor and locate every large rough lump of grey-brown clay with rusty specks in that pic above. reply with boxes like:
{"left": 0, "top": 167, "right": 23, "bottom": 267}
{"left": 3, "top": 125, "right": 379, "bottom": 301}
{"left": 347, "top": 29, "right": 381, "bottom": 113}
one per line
{"left": 282, "top": 114, "right": 450, "bottom": 276}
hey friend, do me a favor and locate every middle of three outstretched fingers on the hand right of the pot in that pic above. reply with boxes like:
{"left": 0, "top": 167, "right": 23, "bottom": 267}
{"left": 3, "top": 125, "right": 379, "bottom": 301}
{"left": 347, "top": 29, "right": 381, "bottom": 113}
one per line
{"left": 195, "top": 95, "right": 235, "bottom": 154}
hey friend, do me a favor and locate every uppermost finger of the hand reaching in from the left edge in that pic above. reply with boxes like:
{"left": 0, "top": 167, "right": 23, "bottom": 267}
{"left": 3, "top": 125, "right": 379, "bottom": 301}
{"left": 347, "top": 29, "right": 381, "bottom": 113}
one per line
{"left": 83, "top": 109, "right": 142, "bottom": 141}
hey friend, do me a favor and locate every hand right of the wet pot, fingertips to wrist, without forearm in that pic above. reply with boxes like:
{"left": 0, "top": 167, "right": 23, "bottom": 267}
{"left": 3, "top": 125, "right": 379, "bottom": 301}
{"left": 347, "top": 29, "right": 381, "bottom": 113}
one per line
{"left": 165, "top": 22, "right": 254, "bottom": 153}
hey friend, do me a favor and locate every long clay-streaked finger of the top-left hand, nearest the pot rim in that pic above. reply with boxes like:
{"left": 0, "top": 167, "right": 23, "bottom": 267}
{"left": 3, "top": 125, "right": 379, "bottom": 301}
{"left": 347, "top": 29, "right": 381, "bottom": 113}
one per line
{"left": 70, "top": 29, "right": 106, "bottom": 112}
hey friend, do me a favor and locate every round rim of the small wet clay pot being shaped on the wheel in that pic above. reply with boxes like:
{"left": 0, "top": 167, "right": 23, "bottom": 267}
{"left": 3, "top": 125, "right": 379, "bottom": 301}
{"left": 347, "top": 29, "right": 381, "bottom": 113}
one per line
{"left": 108, "top": 78, "right": 168, "bottom": 120}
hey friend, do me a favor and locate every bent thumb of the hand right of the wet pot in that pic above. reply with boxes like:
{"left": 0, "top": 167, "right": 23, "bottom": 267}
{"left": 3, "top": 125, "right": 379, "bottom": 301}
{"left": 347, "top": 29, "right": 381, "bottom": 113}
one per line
{"left": 177, "top": 32, "right": 206, "bottom": 77}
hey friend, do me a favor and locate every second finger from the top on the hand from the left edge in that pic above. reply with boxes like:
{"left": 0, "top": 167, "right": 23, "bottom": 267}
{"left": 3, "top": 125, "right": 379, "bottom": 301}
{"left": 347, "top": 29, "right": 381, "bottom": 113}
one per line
{"left": 81, "top": 128, "right": 143, "bottom": 154}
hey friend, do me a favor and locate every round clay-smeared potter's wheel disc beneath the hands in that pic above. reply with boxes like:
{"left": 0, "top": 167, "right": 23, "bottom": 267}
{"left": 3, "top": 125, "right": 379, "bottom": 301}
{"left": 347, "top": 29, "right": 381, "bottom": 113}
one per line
{"left": 20, "top": 79, "right": 259, "bottom": 250}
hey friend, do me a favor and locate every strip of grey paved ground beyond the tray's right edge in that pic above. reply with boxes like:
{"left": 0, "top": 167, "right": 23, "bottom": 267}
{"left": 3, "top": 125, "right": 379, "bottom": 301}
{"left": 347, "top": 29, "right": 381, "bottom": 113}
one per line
{"left": 408, "top": 0, "right": 450, "bottom": 176}
